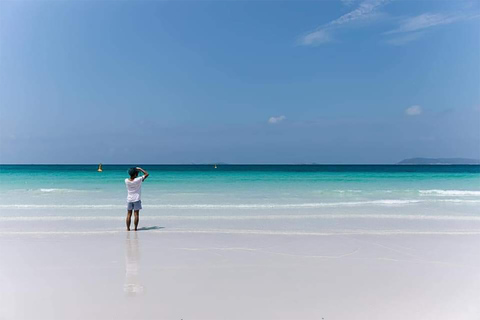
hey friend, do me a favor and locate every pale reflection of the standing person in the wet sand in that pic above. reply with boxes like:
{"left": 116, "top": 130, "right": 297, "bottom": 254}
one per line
{"left": 123, "top": 232, "right": 143, "bottom": 296}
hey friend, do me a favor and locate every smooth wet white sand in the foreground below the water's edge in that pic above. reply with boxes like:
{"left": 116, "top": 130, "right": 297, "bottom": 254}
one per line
{"left": 0, "top": 228, "right": 480, "bottom": 320}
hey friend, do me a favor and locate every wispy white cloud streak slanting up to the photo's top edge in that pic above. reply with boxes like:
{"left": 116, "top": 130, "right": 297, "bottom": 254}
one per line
{"left": 298, "top": 0, "right": 390, "bottom": 46}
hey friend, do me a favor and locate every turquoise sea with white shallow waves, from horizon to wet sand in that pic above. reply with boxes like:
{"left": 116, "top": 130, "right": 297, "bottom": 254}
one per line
{"left": 0, "top": 165, "right": 480, "bottom": 232}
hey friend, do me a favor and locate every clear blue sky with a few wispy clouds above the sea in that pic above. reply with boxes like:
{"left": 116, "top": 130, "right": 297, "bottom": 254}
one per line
{"left": 0, "top": 0, "right": 480, "bottom": 164}
